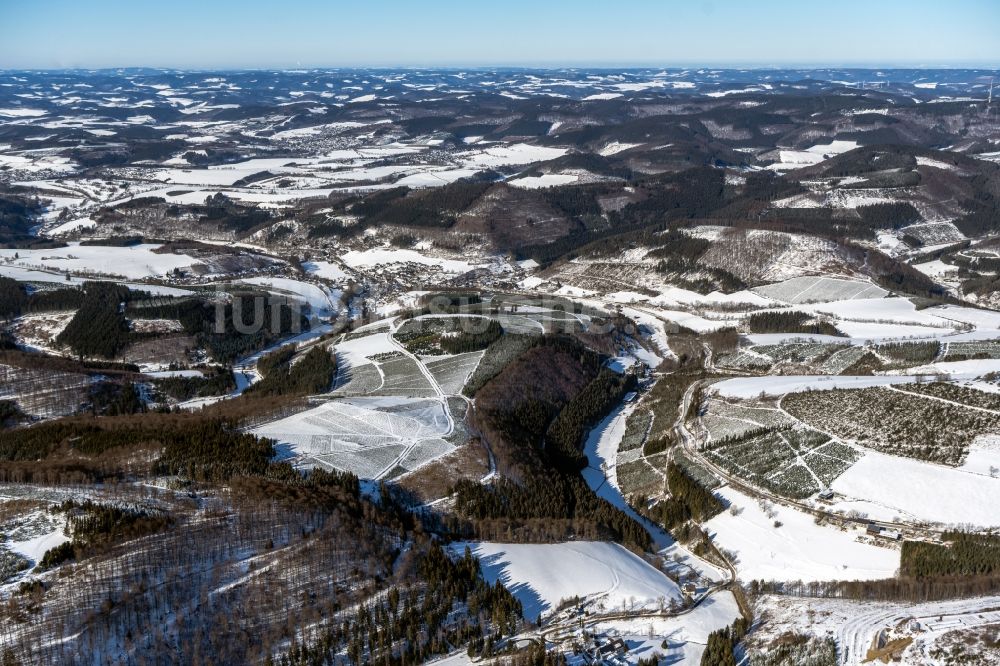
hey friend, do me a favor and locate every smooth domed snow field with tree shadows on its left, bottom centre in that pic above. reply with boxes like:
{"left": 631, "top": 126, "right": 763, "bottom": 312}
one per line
{"left": 452, "top": 541, "right": 680, "bottom": 618}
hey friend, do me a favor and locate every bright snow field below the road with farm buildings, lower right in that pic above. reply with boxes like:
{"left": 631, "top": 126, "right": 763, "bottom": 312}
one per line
{"left": 705, "top": 487, "right": 899, "bottom": 581}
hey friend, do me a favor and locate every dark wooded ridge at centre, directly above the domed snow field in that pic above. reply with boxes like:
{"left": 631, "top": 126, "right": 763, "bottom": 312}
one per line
{"left": 450, "top": 335, "right": 649, "bottom": 549}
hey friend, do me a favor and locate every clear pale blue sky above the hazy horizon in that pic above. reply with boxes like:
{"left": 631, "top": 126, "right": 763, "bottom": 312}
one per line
{"left": 0, "top": 0, "right": 1000, "bottom": 69}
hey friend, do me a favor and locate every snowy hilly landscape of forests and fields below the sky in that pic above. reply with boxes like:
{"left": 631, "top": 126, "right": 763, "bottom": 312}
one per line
{"left": 0, "top": 68, "right": 1000, "bottom": 666}
